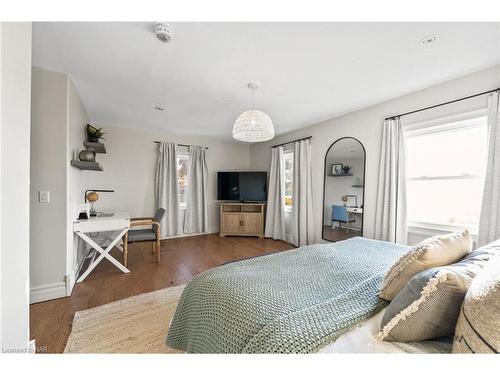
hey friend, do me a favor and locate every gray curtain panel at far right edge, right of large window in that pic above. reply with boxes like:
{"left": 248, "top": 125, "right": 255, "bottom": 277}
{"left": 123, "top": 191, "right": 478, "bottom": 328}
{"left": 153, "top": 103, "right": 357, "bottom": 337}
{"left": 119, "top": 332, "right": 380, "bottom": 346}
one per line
{"left": 477, "top": 92, "right": 500, "bottom": 247}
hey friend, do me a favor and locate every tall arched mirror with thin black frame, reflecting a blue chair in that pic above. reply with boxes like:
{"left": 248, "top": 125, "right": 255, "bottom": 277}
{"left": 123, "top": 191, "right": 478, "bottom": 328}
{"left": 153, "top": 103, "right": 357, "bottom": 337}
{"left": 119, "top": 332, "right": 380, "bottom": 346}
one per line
{"left": 322, "top": 137, "right": 366, "bottom": 242}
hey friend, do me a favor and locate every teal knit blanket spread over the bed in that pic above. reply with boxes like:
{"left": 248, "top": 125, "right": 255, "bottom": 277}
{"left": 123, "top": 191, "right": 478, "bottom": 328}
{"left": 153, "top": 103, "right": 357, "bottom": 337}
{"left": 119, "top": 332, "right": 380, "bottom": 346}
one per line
{"left": 167, "top": 237, "right": 407, "bottom": 353}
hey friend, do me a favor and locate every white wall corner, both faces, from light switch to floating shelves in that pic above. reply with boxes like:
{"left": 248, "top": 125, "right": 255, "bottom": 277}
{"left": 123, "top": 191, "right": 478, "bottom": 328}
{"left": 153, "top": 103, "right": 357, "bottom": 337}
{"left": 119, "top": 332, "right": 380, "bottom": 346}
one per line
{"left": 30, "top": 67, "right": 88, "bottom": 303}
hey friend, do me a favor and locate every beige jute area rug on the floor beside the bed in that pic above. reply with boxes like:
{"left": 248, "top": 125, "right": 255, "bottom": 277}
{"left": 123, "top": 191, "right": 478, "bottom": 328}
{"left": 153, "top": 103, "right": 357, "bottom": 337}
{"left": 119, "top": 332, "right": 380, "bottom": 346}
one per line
{"left": 64, "top": 285, "right": 185, "bottom": 353}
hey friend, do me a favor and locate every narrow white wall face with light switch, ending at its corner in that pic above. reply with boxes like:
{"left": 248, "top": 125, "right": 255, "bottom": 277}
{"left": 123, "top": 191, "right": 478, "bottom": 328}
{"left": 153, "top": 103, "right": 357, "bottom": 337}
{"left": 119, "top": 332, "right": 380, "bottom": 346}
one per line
{"left": 30, "top": 67, "right": 68, "bottom": 303}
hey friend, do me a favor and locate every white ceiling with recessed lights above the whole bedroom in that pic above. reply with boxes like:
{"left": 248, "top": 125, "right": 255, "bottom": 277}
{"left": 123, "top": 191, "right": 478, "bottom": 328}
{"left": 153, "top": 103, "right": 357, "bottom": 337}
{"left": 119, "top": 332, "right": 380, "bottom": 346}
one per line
{"left": 33, "top": 22, "right": 500, "bottom": 139}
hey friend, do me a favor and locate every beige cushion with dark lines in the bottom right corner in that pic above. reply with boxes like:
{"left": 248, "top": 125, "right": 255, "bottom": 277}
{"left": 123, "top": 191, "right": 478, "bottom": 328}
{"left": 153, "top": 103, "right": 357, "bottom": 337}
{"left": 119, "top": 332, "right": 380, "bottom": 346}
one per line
{"left": 453, "top": 256, "right": 500, "bottom": 353}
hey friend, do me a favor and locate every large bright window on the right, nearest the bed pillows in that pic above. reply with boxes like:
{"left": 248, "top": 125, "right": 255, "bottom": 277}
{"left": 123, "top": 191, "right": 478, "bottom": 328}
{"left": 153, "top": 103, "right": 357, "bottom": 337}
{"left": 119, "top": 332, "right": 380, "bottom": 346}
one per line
{"left": 406, "top": 116, "right": 487, "bottom": 233}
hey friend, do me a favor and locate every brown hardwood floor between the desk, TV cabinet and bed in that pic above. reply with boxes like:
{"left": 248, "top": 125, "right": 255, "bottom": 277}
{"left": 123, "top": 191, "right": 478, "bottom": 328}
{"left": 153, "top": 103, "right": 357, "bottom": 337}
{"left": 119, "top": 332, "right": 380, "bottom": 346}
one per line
{"left": 30, "top": 234, "right": 294, "bottom": 353}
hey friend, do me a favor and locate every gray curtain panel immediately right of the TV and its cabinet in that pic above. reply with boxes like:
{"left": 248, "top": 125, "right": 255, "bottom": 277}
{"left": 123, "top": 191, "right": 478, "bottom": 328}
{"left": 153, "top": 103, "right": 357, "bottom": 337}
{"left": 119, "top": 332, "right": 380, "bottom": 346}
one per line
{"left": 265, "top": 146, "right": 286, "bottom": 241}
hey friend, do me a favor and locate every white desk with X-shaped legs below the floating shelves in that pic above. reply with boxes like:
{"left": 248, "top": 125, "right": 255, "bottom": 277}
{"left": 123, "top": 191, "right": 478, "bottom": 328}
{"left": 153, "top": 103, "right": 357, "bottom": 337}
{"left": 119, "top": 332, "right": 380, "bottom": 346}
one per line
{"left": 73, "top": 211, "right": 130, "bottom": 283}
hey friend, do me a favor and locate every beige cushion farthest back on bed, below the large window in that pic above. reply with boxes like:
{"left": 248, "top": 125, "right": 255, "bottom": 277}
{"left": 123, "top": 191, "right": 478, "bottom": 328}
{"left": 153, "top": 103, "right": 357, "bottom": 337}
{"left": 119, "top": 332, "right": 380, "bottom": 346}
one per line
{"left": 380, "top": 230, "right": 472, "bottom": 301}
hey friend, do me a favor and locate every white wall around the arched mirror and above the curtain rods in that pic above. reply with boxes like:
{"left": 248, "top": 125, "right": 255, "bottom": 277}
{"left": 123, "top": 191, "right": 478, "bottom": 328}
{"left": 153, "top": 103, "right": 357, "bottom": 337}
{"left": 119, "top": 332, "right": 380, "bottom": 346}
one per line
{"left": 250, "top": 65, "right": 500, "bottom": 242}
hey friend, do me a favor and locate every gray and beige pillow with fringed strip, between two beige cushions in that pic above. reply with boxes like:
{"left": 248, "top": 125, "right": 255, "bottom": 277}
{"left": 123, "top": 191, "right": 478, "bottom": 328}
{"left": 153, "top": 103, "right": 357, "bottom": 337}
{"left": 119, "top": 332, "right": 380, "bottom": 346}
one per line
{"left": 379, "top": 241, "right": 500, "bottom": 342}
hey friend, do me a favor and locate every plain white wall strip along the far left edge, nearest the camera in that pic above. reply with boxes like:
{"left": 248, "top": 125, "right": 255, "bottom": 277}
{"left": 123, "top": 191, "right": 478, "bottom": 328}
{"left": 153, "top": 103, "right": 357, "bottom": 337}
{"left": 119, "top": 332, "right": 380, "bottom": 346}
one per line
{"left": 0, "top": 22, "right": 31, "bottom": 351}
